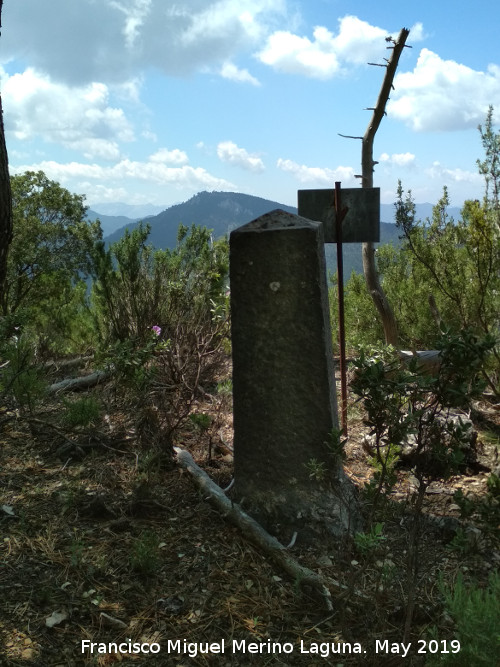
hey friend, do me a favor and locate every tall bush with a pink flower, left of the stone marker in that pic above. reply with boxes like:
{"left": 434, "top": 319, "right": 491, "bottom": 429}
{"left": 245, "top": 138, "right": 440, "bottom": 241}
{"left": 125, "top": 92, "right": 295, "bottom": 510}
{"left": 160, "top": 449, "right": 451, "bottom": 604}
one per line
{"left": 93, "top": 225, "right": 229, "bottom": 443}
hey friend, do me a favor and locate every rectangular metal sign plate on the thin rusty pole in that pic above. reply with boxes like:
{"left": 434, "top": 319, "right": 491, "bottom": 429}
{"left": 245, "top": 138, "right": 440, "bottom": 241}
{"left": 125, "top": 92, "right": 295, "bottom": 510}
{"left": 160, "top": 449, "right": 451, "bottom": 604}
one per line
{"left": 298, "top": 188, "right": 380, "bottom": 243}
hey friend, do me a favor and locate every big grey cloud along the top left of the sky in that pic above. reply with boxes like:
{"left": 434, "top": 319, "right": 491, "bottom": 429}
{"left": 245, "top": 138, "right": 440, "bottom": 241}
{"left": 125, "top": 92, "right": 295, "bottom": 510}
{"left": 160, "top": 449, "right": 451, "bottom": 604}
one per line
{"left": 2, "top": 0, "right": 287, "bottom": 85}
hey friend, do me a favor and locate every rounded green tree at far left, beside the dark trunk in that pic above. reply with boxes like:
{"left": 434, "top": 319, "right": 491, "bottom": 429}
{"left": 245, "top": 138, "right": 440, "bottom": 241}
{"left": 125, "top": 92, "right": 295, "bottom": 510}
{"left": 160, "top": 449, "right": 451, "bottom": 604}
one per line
{"left": 0, "top": 171, "right": 102, "bottom": 355}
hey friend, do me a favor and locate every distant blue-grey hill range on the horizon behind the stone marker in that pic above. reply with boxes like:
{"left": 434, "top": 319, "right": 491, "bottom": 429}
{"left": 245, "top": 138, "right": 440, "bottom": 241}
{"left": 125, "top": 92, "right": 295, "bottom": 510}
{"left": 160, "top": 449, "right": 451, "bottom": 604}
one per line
{"left": 87, "top": 192, "right": 460, "bottom": 279}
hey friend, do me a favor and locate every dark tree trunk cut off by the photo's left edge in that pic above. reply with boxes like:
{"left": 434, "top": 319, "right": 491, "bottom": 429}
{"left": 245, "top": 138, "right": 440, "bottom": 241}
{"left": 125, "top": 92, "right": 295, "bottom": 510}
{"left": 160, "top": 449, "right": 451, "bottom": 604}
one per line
{"left": 0, "top": 0, "right": 12, "bottom": 314}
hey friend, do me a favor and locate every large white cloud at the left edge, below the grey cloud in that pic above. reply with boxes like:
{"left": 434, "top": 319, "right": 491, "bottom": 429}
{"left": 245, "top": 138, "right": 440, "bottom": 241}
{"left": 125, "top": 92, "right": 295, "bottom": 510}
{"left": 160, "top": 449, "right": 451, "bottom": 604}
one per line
{"left": 2, "top": 68, "right": 134, "bottom": 160}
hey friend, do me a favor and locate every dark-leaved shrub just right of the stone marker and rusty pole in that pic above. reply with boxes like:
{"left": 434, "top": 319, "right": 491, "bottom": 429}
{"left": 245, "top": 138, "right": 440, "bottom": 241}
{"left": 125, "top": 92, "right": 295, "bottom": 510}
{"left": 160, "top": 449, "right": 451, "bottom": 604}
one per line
{"left": 351, "top": 331, "right": 494, "bottom": 501}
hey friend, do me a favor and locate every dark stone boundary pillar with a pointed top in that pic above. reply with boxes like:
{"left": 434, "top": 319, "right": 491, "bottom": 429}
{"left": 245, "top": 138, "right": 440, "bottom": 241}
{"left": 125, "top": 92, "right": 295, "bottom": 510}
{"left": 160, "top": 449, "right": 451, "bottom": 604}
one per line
{"left": 230, "top": 210, "right": 359, "bottom": 537}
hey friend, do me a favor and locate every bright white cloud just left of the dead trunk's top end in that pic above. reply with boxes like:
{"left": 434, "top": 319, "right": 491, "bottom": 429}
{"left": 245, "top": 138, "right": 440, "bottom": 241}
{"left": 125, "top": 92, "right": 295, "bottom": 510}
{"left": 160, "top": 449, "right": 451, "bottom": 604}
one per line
{"left": 257, "top": 16, "right": 396, "bottom": 79}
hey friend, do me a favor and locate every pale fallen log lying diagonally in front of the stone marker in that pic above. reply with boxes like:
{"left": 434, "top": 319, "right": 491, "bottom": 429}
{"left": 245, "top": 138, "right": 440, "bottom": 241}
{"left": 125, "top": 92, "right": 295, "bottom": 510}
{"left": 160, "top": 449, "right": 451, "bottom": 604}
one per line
{"left": 174, "top": 447, "right": 368, "bottom": 611}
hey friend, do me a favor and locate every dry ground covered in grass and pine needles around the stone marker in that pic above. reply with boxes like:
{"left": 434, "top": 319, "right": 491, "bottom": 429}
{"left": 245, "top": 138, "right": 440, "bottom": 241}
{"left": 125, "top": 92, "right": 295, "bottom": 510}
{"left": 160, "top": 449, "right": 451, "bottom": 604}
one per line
{"left": 0, "top": 366, "right": 499, "bottom": 667}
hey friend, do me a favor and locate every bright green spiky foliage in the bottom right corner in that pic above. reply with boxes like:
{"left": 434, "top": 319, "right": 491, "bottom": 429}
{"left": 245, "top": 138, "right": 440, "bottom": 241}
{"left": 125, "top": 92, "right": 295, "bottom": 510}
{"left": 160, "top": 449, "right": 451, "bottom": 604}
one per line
{"left": 426, "top": 572, "right": 500, "bottom": 667}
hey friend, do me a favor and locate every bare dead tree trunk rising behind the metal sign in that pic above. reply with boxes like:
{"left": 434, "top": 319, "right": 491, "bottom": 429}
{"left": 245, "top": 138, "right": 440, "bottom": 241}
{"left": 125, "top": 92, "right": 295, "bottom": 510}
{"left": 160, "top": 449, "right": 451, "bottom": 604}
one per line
{"left": 361, "top": 28, "right": 410, "bottom": 347}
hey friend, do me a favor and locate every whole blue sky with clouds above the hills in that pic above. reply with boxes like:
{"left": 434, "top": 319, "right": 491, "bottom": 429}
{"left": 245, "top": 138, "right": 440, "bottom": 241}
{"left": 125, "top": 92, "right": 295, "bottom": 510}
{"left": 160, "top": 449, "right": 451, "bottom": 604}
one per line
{"left": 0, "top": 0, "right": 500, "bottom": 214}
